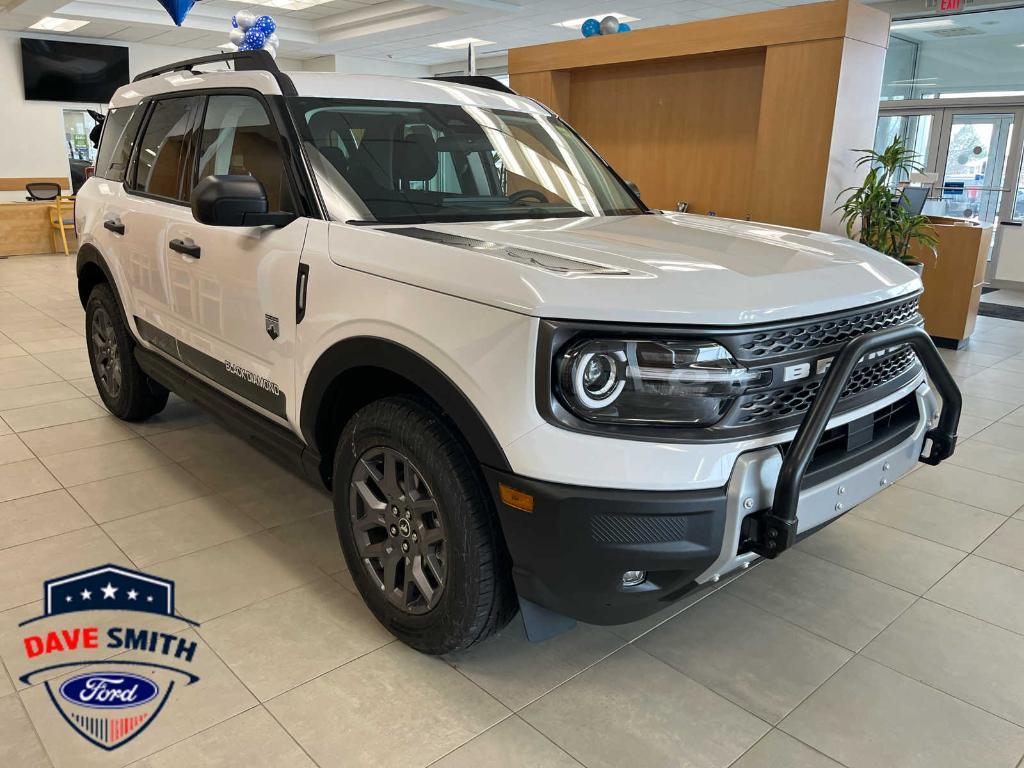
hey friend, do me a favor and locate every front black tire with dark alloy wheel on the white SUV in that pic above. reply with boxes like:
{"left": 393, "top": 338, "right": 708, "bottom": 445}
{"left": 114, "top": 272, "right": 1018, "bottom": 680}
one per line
{"left": 334, "top": 396, "right": 518, "bottom": 654}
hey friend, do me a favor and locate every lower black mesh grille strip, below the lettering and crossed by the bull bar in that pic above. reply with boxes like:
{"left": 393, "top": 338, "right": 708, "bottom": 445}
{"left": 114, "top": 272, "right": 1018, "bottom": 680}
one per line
{"left": 734, "top": 347, "right": 918, "bottom": 425}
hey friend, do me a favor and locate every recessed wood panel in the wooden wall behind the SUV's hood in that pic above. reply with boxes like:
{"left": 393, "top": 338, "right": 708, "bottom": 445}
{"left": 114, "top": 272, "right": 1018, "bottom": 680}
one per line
{"left": 569, "top": 50, "right": 765, "bottom": 218}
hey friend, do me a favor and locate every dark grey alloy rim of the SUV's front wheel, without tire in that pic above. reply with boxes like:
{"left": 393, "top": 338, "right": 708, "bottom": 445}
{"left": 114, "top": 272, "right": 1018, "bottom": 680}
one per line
{"left": 349, "top": 446, "right": 447, "bottom": 613}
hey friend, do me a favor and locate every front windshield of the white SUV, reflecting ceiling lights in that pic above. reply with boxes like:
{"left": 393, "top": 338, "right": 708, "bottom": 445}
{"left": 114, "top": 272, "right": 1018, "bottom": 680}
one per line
{"left": 290, "top": 98, "right": 644, "bottom": 223}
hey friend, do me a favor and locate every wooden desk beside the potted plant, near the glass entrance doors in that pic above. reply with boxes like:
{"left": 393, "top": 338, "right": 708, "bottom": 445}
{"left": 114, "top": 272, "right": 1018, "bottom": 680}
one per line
{"left": 910, "top": 216, "right": 992, "bottom": 349}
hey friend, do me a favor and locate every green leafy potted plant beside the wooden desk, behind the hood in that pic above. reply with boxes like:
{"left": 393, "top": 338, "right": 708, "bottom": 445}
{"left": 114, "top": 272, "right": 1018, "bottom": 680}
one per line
{"left": 836, "top": 136, "right": 938, "bottom": 274}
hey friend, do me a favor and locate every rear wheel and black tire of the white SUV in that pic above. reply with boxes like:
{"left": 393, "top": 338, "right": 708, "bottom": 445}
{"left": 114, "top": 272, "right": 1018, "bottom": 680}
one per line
{"left": 85, "top": 283, "right": 170, "bottom": 421}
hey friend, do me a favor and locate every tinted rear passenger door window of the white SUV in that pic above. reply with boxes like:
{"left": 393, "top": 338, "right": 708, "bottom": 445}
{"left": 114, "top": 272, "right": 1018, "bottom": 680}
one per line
{"left": 134, "top": 96, "right": 200, "bottom": 200}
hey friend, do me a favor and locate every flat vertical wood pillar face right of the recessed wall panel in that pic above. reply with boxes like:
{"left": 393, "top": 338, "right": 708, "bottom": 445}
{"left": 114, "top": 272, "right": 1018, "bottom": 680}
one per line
{"left": 751, "top": 38, "right": 843, "bottom": 229}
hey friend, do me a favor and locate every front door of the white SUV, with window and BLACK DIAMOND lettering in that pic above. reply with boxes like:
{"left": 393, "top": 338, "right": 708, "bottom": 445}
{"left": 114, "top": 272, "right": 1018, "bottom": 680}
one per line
{"left": 164, "top": 91, "right": 307, "bottom": 422}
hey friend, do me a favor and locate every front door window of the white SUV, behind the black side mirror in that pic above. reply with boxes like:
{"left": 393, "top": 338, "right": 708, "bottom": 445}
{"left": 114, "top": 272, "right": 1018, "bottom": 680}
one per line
{"left": 199, "top": 95, "right": 292, "bottom": 211}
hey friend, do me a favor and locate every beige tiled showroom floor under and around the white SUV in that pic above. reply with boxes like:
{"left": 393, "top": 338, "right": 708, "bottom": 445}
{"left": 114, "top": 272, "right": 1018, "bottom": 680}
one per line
{"left": 0, "top": 257, "right": 1024, "bottom": 768}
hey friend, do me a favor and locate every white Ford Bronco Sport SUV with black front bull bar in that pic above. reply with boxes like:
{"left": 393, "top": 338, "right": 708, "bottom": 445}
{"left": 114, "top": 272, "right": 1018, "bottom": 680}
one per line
{"left": 76, "top": 52, "right": 961, "bottom": 653}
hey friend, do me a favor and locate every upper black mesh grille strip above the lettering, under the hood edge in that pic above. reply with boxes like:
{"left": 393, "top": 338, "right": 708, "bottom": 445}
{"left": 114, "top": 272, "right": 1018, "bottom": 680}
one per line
{"left": 736, "top": 296, "right": 921, "bottom": 360}
